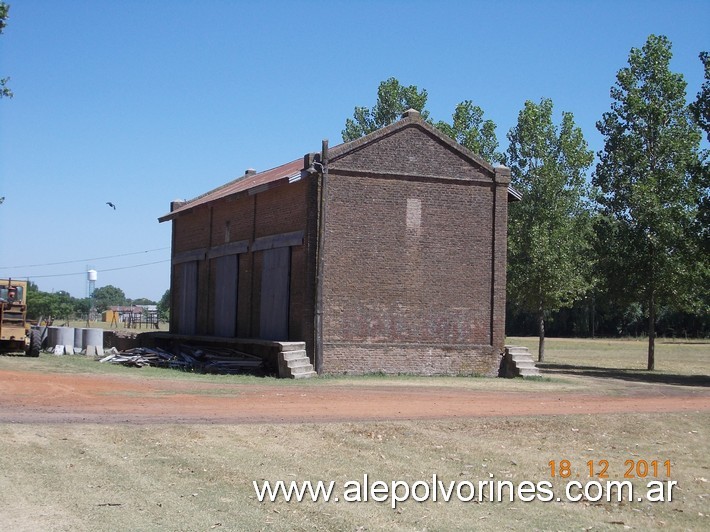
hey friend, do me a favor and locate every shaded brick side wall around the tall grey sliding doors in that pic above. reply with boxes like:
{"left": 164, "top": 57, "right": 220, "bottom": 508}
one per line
{"left": 171, "top": 178, "right": 313, "bottom": 344}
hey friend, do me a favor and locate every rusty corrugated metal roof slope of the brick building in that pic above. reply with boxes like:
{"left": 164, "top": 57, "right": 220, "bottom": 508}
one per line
{"left": 158, "top": 158, "right": 303, "bottom": 222}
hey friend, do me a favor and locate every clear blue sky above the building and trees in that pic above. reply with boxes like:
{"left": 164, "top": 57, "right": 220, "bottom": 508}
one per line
{"left": 0, "top": 0, "right": 710, "bottom": 299}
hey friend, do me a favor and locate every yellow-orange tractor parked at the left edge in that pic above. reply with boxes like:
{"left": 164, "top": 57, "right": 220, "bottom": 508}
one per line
{"left": 0, "top": 279, "right": 42, "bottom": 357}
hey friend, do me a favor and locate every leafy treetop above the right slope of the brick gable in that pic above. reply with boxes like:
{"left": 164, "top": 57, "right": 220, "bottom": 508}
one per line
{"left": 435, "top": 100, "right": 504, "bottom": 163}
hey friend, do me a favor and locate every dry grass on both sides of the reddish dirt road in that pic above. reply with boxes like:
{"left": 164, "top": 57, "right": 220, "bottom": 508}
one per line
{"left": 0, "top": 338, "right": 710, "bottom": 530}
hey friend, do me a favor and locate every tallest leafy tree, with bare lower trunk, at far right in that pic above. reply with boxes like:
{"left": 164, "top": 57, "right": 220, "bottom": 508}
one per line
{"left": 594, "top": 35, "right": 708, "bottom": 370}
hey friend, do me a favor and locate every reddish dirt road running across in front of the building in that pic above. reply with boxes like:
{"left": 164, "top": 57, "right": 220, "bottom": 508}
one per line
{"left": 0, "top": 371, "right": 710, "bottom": 424}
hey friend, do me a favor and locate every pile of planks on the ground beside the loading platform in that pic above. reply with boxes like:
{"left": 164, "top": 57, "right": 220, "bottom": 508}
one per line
{"left": 100, "top": 345, "right": 264, "bottom": 374}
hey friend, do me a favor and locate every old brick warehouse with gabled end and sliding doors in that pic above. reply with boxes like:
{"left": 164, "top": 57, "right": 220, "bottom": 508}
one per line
{"left": 160, "top": 111, "right": 510, "bottom": 375}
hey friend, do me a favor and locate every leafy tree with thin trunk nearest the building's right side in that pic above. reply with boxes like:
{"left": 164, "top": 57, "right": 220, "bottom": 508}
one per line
{"left": 508, "top": 99, "right": 593, "bottom": 362}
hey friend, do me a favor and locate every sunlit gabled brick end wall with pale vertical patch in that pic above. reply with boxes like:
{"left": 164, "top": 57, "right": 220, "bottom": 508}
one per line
{"left": 323, "top": 122, "right": 507, "bottom": 374}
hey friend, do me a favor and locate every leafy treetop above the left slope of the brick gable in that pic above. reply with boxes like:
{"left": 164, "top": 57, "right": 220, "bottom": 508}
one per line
{"left": 342, "top": 78, "right": 429, "bottom": 142}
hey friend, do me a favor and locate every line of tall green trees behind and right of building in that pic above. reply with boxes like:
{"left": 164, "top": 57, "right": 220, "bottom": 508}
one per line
{"left": 342, "top": 35, "right": 710, "bottom": 370}
